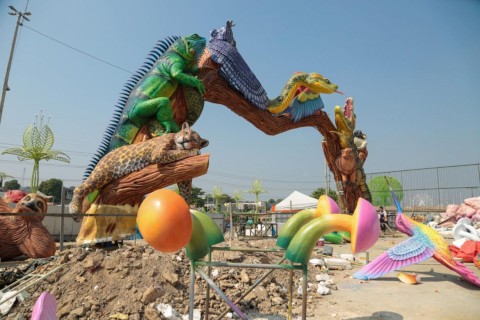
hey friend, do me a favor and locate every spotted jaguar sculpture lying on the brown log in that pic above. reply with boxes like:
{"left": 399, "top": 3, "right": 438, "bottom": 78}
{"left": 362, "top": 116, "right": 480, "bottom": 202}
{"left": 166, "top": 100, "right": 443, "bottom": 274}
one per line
{"left": 70, "top": 123, "right": 208, "bottom": 213}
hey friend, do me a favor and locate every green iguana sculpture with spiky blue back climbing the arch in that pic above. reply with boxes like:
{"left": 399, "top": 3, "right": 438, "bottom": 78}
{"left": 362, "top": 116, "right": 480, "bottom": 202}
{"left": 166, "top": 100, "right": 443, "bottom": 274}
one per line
{"left": 84, "top": 34, "right": 206, "bottom": 178}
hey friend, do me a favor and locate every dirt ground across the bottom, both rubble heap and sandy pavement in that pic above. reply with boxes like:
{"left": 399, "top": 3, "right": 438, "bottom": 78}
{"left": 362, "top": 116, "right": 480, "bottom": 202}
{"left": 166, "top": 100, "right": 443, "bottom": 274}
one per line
{"left": 0, "top": 233, "right": 480, "bottom": 320}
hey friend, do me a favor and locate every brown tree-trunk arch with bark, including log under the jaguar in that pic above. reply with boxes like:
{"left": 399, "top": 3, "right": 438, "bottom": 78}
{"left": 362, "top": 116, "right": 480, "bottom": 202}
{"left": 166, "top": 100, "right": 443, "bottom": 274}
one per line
{"left": 77, "top": 47, "right": 370, "bottom": 243}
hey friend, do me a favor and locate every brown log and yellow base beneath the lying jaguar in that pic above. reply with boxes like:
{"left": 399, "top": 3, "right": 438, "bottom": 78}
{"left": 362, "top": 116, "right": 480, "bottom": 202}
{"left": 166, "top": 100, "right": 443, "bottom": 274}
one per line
{"left": 76, "top": 152, "right": 210, "bottom": 245}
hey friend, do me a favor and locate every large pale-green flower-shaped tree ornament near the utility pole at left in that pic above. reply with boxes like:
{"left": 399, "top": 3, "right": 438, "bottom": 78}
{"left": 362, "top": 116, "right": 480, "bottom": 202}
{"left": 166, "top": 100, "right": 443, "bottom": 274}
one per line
{"left": 2, "top": 113, "right": 70, "bottom": 192}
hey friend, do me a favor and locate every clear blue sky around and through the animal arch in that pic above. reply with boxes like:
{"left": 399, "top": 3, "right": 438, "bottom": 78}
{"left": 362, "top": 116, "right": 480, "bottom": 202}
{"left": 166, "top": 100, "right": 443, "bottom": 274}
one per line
{"left": 0, "top": 0, "right": 480, "bottom": 200}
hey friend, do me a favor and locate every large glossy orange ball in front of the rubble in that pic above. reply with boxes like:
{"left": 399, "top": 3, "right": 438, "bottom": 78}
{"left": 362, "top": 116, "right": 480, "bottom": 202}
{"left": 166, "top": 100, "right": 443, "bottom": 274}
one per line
{"left": 137, "top": 189, "right": 192, "bottom": 253}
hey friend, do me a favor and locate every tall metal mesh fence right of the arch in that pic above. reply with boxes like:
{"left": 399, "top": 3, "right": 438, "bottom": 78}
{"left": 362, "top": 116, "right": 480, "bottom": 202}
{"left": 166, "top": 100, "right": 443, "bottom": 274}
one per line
{"left": 367, "top": 163, "right": 480, "bottom": 211}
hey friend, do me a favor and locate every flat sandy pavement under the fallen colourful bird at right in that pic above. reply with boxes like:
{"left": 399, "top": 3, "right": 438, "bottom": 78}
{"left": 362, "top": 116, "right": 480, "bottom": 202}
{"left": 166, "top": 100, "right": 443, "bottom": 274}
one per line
{"left": 311, "top": 233, "right": 480, "bottom": 320}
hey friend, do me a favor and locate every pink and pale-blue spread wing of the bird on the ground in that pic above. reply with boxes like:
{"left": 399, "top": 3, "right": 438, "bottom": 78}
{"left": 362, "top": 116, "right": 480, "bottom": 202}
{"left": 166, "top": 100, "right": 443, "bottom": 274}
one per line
{"left": 353, "top": 236, "right": 434, "bottom": 280}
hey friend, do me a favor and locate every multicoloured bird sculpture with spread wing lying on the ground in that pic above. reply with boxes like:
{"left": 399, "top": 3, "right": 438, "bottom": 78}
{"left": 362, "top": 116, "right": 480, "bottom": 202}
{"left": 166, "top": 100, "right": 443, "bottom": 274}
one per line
{"left": 353, "top": 180, "right": 480, "bottom": 287}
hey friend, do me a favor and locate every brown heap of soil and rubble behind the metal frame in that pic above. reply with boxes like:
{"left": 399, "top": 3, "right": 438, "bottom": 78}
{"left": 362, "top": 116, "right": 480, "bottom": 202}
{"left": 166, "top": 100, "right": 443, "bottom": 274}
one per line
{"left": 0, "top": 239, "right": 342, "bottom": 320}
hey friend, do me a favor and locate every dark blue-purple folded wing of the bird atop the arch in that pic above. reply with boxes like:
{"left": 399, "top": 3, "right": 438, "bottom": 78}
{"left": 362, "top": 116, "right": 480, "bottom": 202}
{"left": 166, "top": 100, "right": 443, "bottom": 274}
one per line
{"left": 208, "top": 40, "right": 268, "bottom": 109}
